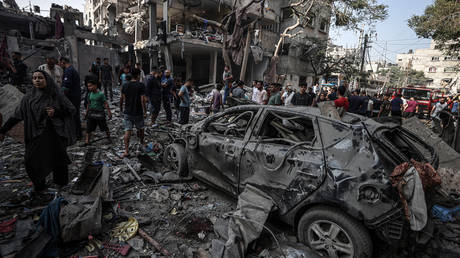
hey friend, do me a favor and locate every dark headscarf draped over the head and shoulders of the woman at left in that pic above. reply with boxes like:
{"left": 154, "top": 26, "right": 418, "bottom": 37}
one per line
{"left": 14, "top": 70, "right": 77, "bottom": 145}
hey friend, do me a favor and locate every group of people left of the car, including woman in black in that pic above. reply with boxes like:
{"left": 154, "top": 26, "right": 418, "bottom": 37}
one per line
{"left": 0, "top": 52, "right": 193, "bottom": 197}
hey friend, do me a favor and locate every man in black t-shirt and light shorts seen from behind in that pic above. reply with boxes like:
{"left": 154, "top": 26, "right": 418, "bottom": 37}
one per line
{"left": 120, "top": 69, "right": 147, "bottom": 157}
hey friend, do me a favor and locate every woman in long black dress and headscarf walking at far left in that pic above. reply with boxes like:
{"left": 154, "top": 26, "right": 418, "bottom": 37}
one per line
{"left": 0, "top": 71, "right": 76, "bottom": 196}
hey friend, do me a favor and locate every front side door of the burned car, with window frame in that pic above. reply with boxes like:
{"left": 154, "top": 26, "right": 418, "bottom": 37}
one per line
{"left": 189, "top": 109, "right": 258, "bottom": 195}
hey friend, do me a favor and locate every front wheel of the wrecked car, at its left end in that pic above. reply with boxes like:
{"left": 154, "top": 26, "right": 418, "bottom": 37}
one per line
{"left": 163, "top": 143, "right": 188, "bottom": 177}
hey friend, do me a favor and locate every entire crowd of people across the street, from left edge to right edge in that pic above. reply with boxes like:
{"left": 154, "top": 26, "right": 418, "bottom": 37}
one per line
{"left": 0, "top": 52, "right": 459, "bottom": 198}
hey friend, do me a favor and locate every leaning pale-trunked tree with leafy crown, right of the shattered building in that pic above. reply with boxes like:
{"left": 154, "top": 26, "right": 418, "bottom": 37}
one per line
{"left": 265, "top": 0, "right": 388, "bottom": 82}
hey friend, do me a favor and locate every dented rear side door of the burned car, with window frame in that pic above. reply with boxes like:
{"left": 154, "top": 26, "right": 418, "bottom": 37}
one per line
{"left": 240, "top": 110, "right": 325, "bottom": 212}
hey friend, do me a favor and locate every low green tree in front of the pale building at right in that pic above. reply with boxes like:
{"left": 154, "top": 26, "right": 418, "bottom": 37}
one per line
{"left": 378, "top": 66, "right": 428, "bottom": 88}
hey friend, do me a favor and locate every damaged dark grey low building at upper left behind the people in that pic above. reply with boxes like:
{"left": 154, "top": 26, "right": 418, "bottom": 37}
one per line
{"left": 0, "top": 4, "right": 126, "bottom": 83}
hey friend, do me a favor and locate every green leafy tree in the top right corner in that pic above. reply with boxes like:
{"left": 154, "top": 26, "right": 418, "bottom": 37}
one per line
{"left": 408, "top": 0, "right": 460, "bottom": 53}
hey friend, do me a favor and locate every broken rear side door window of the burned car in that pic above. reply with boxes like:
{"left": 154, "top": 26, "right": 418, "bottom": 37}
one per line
{"left": 256, "top": 112, "right": 315, "bottom": 145}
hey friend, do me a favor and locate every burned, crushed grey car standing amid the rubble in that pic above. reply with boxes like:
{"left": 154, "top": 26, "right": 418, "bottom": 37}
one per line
{"left": 165, "top": 105, "right": 438, "bottom": 257}
